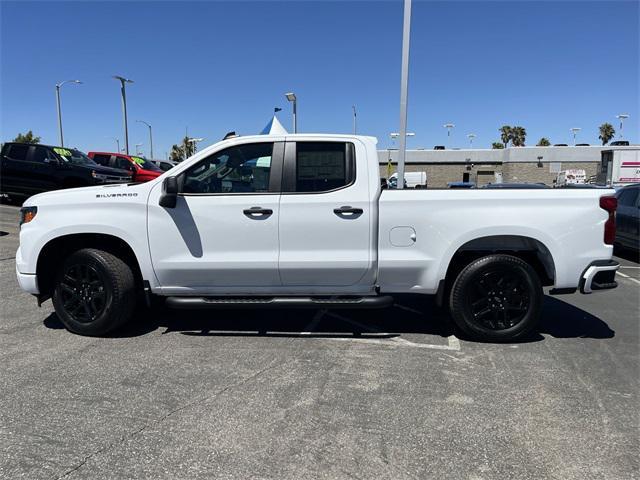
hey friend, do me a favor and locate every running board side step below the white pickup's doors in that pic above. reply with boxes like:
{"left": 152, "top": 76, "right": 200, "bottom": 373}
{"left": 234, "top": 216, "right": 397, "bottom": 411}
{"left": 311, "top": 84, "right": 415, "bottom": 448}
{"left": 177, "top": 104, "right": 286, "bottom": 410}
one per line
{"left": 166, "top": 296, "right": 393, "bottom": 309}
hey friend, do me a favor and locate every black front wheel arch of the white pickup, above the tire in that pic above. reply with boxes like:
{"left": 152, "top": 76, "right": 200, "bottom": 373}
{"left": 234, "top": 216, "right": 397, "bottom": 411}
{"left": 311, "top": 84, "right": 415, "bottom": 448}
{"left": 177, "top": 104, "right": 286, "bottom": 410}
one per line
{"left": 36, "top": 233, "right": 143, "bottom": 298}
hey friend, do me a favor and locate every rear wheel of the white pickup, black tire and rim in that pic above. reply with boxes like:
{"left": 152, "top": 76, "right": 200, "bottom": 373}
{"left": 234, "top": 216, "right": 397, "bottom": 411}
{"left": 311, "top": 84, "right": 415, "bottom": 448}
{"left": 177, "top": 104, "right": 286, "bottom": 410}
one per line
{"left": 449, "top": 255, "right": 543, "bottom": 342}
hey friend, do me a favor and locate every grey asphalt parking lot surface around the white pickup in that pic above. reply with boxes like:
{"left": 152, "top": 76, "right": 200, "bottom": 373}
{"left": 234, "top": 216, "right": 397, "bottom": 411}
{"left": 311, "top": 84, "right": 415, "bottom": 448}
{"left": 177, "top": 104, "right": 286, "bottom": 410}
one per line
{"left": 0, "top": 205, "right": 640, "bottom": 480}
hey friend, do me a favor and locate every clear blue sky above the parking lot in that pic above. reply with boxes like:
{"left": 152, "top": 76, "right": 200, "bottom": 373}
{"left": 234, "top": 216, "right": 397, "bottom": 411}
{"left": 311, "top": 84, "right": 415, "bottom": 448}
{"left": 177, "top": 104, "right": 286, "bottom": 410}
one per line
{"left": 0, "top": 0, "right": 640, "bottom": 157}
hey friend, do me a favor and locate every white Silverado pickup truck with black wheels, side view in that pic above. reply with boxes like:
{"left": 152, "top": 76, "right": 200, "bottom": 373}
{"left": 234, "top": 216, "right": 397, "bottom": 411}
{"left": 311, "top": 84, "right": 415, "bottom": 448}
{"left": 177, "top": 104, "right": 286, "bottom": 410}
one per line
{"left": 16, "top": 134, "right": 618, "bottom": 341}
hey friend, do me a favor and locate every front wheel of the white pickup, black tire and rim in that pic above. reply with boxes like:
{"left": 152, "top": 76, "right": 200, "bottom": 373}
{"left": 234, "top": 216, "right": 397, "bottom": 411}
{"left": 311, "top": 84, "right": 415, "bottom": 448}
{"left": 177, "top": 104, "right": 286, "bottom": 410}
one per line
{"left": 52, "top": 248, "right": 136, "bottom": 336}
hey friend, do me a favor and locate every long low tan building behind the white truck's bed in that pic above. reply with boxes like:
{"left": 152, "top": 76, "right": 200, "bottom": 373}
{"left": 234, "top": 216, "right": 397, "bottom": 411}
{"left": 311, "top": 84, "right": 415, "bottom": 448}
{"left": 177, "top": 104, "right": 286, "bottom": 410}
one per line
{"left": 378, "top": 145, "right": 637, "bottom": 188}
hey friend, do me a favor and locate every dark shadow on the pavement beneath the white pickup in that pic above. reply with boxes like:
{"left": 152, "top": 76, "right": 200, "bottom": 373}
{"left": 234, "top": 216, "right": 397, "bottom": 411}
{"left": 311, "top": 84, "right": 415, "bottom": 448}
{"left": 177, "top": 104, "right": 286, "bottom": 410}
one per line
{"left": 44, "top": 296, "right": 615, "bottom": 343}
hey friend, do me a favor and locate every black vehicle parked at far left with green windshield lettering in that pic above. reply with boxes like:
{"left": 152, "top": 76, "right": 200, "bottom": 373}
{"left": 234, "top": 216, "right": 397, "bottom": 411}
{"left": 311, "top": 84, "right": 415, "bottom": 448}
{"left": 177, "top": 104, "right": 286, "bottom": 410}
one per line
{"left": 0, "top": 142, "right": 131, "bottom": 197}
